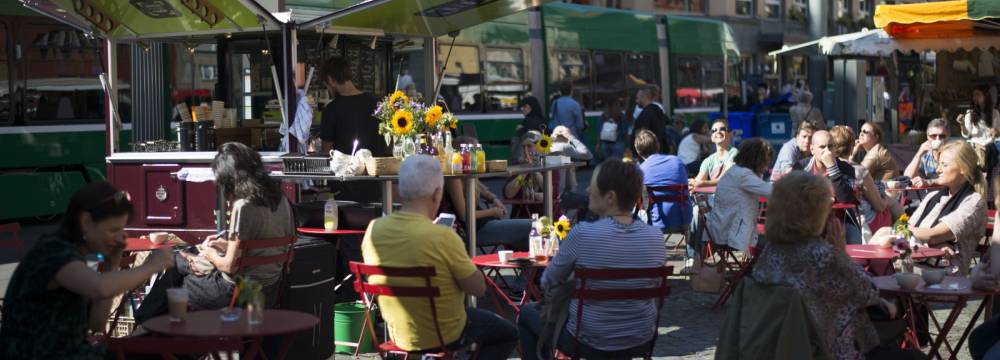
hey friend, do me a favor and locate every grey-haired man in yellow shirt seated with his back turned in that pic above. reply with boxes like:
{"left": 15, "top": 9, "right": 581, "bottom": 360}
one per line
{"left": 361, "top": 155, "right": 517, "bottom": 359}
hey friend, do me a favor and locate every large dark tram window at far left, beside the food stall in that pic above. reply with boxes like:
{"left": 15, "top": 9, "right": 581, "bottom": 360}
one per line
{"left": 18, "top": 24, "right": 104, "bottom": 122}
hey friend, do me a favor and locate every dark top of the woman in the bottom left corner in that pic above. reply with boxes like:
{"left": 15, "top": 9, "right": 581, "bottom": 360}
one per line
{"left": 0, "top": 239, "right": 104, "bottom": 359}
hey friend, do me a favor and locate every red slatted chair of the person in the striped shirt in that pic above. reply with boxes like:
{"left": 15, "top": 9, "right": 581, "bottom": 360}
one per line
{"left": 556, "top": 266, "right": 674, "bottom": 359}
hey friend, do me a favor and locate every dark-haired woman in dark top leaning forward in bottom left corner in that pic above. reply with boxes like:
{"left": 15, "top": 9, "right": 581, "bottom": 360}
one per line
{"left": 0, "top": 181, "right": 174, "bottom": 359}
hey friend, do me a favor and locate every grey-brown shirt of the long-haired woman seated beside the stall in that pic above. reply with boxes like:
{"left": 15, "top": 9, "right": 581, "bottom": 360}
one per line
{"left": 229, "top": 198, "right": 295, "bottom": 286}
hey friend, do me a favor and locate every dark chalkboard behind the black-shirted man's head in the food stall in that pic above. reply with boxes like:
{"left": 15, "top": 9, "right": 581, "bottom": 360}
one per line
{"left": 299, "top": 35, "right": 391, "bottom": 102}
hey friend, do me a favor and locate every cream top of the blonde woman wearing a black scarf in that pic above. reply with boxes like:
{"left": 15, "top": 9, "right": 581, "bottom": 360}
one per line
{"left": 909, "top": 189, "right": 986, "bottom": 275}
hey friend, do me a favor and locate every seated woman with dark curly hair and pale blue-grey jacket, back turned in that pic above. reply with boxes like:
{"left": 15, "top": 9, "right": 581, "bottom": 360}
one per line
{"left": 707, "top": 138, "right": 774, "bottom": 251}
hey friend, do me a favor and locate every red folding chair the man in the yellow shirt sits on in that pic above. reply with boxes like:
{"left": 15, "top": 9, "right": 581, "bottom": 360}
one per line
{"left": 350, "top": 261, "right": 476, "bottom": 360}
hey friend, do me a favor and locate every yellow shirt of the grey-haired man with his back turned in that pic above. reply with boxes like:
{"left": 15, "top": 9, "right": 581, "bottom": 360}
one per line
{"left": 361, "top": 211, "right": 476, "bottom": 350}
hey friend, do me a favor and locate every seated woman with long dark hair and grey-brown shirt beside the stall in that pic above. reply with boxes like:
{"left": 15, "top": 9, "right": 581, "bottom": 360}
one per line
{"left": 136, "top": 142, "right": 295, "bottom": 322}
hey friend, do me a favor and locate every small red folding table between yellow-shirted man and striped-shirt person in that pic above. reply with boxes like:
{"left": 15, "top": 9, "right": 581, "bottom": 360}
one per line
{"left": 472, "top": 251, "right": 549, "bottom": 315}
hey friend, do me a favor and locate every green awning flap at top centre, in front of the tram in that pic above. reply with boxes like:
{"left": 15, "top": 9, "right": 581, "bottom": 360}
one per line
{"left": 300, "top": 0, "right": 552, "bottom": 37}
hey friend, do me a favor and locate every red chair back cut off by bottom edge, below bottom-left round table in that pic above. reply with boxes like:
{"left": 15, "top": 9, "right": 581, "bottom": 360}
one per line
{"left": 107, "top": 336, "right": 242, "bottom": 360}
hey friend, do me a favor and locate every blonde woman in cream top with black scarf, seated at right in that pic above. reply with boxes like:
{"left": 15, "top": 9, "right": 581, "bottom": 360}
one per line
{"left": 872, "top": 141, "right": 986, "bottom": 275}
